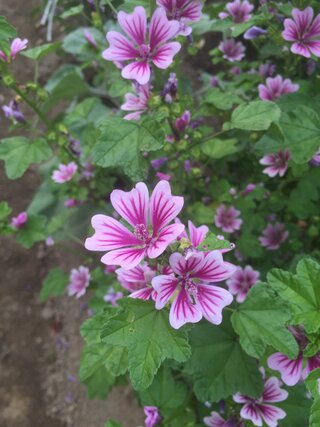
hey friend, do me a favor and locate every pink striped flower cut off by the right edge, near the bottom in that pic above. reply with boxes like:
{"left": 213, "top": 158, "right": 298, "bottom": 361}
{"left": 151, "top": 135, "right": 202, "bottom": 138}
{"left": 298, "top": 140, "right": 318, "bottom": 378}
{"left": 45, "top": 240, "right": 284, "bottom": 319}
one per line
{"left": 267, "top": 352, "right": 320, "bottom": 386}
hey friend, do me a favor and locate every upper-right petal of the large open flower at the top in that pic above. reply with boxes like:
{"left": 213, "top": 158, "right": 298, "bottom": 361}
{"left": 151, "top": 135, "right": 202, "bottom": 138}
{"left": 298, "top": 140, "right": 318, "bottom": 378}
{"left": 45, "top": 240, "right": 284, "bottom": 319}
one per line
{"left": 149, "top": 8, "right": 180, "bottom": 51}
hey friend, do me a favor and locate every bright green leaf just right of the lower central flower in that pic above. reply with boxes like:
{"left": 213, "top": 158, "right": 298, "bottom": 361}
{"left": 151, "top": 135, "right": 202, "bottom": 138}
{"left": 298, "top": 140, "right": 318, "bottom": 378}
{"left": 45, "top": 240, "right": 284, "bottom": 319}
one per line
{"left": 231, "top": 283, "right": 298, "bottom": 359}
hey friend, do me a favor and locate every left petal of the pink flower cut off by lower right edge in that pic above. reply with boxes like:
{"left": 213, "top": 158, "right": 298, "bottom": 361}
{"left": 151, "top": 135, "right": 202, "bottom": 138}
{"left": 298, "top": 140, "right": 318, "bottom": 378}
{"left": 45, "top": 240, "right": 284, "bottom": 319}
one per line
{"left": 268, "top": 353, "right": 303, "bottom": 386}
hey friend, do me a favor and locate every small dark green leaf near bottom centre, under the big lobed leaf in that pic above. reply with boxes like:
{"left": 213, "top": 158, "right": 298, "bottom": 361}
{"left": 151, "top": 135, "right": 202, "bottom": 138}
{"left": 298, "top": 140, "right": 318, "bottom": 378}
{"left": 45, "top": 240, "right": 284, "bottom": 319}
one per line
{"left": 139, "top": 367, "right": 188, "bottom": 412}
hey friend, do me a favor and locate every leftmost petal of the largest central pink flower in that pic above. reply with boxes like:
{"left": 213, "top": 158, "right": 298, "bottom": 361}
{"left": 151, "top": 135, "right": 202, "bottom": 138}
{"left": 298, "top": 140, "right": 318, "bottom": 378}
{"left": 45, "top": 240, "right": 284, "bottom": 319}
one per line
{"left": 85, "top": 215, "right": 141, "bottom": 251}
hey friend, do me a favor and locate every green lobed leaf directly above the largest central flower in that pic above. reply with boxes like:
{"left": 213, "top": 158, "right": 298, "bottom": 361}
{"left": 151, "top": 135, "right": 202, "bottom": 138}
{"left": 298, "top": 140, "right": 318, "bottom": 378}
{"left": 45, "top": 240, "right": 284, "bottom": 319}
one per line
{"left": 93, "top": 117, "right": 165, "bottom": 181}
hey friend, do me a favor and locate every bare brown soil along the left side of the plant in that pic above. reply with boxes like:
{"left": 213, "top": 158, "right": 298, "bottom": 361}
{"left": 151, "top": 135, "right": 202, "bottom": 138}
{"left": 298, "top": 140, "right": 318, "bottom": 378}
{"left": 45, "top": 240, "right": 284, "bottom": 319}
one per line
{"left": 0, "top": 0, "right": 144, "bottom": 427}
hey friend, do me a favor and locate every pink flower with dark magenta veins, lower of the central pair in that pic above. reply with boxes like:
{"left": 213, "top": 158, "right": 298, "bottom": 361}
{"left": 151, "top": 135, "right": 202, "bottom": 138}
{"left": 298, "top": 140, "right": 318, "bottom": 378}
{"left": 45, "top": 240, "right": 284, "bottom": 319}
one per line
{"left": 152, "top": 251, "right": 235, "bottom": 329}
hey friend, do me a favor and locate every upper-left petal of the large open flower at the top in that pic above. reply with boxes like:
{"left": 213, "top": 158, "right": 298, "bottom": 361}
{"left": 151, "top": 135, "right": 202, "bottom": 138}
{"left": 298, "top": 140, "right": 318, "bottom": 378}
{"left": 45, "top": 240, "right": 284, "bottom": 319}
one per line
{"left": 118, "top": 6, "right": 147, "bottom": 45}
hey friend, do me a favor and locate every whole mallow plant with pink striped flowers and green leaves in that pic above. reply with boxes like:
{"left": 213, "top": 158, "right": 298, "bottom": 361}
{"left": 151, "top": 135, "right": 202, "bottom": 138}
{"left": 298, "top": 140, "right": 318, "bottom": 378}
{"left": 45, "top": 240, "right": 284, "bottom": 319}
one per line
{"left": 0, "top": 0, "right": 320, "bottom": 427}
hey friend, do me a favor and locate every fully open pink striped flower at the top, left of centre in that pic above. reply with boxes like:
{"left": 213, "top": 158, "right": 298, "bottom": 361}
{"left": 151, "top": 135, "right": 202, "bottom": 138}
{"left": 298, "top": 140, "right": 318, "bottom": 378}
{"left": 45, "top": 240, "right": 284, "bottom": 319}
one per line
{"left": 102, "top": 6, "right": 181, "bottom": 85}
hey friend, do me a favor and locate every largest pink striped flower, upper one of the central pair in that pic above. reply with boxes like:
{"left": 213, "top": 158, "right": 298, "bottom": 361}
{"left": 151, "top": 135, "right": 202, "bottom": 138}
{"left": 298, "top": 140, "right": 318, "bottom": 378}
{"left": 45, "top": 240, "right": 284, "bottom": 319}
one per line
{"left": 85, "top": 181, "right": 184, "bottom": 270}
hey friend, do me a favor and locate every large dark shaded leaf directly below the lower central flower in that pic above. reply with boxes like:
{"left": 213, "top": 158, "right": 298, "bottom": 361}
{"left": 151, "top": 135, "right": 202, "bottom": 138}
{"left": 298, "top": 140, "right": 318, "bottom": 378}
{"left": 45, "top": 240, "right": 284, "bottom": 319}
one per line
{"left": 187, "top": 314, "right": 263, "bottom": 402}
